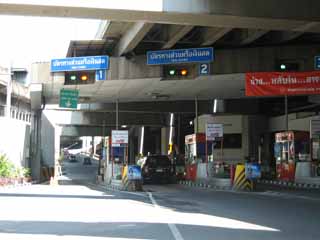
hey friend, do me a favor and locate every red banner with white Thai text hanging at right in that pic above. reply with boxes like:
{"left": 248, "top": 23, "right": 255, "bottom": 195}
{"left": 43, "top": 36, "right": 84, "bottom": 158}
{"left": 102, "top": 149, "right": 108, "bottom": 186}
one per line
{"left": 246, "top": 71, "right": 320, "bottom": 96}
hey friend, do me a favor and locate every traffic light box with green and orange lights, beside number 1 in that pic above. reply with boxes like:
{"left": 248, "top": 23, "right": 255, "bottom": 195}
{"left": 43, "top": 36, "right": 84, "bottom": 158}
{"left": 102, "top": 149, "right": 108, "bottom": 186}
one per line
{"left": 64, "top": 71, "right": 95, "bottom": 85}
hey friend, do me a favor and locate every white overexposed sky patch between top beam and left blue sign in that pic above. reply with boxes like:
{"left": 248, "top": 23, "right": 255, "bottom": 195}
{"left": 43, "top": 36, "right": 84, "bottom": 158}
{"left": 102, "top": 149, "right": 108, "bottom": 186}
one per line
{"left": 0, "top": 16, "right": 100, "bottom": 68}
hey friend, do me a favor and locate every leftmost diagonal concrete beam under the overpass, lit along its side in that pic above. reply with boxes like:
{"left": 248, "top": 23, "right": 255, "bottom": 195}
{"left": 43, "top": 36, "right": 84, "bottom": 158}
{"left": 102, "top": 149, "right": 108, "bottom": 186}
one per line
{"left": 115, "top": 22, "right": 154, "bottom": 56}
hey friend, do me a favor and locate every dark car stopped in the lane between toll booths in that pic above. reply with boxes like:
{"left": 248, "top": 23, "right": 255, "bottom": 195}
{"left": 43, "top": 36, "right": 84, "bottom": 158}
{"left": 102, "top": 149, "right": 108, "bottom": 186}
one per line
{"left": 140, "top": 155, "right": 173, "bottom": 182}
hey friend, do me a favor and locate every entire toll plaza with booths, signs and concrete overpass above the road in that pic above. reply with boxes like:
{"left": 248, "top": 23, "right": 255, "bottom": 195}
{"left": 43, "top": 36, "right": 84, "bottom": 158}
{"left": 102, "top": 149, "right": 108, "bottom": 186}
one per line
{"left": 1, "top": 1, "right": 319, "bottom": 189}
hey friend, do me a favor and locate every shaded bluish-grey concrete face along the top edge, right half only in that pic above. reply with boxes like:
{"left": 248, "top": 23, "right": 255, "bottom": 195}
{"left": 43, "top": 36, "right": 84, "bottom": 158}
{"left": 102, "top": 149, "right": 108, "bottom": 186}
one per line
{"left": 163, "top": 0, "right": 320, "bottom": 21}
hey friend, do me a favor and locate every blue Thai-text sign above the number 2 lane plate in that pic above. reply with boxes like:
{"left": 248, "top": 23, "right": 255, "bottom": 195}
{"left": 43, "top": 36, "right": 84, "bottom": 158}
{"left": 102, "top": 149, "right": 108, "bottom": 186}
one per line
{"left": 147, "top": 48, "right": 214, "bottom": 65}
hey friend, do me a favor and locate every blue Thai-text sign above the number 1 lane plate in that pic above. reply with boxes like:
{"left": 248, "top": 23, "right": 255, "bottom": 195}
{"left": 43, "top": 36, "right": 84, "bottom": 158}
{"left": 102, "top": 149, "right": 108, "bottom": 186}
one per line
{"left": 51, "top": 56, "right": 109, "bottom": 72}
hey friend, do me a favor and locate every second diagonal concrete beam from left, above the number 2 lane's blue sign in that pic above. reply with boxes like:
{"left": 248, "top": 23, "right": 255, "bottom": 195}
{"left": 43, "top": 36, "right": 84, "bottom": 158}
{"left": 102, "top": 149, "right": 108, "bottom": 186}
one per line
{"left": 162, "top": 25, "right": 194, "bottom": 49}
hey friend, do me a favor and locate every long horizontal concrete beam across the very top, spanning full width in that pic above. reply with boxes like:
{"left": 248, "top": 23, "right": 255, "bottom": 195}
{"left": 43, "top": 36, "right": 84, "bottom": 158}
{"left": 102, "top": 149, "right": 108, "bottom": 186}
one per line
{"left": 0, "top": 0, "right": 320, "bottom": 32}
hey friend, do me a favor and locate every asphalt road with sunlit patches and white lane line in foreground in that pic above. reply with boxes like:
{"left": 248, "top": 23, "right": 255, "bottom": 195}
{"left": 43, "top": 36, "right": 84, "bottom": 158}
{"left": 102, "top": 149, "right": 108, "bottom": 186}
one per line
{"left": 0, "top": 158, "right": 320, "bottom": 240}
